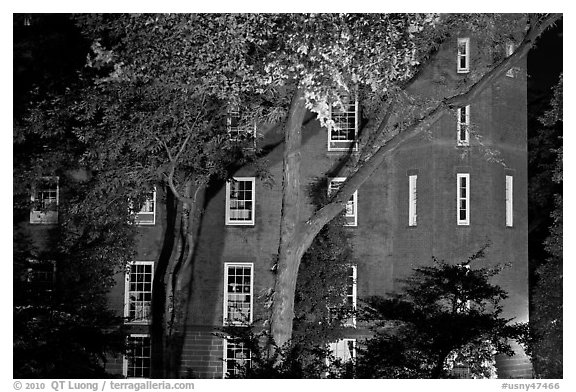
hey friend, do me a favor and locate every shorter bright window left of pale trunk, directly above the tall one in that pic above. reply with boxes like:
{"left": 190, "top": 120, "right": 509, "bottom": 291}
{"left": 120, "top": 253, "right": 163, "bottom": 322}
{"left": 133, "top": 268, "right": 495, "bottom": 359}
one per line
{"left": 226, "top": 177, "right": 255, "bottom": 225}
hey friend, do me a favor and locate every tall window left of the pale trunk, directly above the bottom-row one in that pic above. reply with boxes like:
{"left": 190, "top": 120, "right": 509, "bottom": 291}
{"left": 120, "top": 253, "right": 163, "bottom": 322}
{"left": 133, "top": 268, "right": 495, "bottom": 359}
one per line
{"left": 224, "top": 263, "right": 253, "bottom": 325}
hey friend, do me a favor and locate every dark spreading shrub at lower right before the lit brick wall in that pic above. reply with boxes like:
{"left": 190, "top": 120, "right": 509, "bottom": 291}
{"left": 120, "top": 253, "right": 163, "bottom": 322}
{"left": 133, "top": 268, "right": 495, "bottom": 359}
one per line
{"left": 356, "top": 248, "right": 521, "bottom": 378}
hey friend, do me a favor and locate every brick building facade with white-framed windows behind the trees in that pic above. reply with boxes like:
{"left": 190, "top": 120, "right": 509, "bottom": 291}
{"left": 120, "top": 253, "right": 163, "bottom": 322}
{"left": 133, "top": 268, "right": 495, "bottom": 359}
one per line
{"left": 18, "top": 29, "right": 531, "bottom": 378}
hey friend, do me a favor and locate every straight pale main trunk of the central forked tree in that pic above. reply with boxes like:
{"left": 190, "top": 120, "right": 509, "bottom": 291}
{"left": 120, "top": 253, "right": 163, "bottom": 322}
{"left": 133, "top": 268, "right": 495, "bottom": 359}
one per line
{"left": 270, "top": 88, "right": 306, "bottom": 346}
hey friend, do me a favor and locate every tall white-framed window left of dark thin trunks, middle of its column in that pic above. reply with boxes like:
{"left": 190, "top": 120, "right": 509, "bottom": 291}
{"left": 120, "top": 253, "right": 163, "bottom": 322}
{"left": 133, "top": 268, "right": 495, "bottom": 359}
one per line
{"left": 124, "top": 261, "right": 154, "bottom": 323}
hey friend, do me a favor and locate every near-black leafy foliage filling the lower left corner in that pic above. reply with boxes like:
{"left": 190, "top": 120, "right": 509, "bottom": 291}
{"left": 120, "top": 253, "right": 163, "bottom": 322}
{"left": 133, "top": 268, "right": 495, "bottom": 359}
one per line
{"left": 14, "top": 177, "right": 133, "bottom": 378}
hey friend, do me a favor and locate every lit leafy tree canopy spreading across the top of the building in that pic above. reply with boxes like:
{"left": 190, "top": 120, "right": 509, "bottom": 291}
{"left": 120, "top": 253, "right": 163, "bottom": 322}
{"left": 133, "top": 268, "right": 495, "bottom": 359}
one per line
{"left": 14, "top": 14, "right": 560, "bottom": 376}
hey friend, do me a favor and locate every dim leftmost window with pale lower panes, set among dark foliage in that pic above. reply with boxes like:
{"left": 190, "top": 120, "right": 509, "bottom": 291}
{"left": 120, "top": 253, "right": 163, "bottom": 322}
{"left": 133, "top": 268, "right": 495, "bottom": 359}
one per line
{"left": 30, "top": 177, "right": 59, "bottom": 224}
